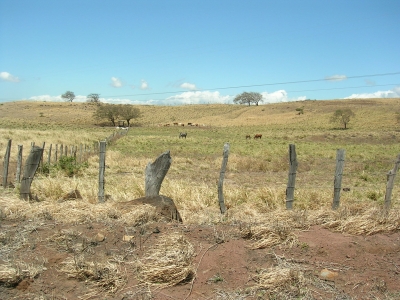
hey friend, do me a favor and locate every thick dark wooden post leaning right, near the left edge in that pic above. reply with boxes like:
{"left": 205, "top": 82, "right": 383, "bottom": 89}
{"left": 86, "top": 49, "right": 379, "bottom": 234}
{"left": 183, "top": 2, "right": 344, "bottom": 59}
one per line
{"left": 19, "top": 146, "right": 43, "bottom": 200}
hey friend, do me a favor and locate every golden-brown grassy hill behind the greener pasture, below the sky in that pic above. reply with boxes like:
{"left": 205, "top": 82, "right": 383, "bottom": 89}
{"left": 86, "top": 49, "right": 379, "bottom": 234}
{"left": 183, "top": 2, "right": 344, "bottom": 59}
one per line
{"left": 0, "top": 99, "right": 400, "bottom": 130}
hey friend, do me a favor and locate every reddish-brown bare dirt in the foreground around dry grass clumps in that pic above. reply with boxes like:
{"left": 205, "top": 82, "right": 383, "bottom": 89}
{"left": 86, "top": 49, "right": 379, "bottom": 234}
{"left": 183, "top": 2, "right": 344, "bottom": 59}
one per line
{"left": 0, "top": 221, "right": 400, "bottom": 300}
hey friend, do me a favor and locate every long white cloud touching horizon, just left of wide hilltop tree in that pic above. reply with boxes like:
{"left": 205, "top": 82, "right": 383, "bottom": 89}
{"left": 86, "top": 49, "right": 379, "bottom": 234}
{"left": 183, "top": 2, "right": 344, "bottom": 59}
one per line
{"left": 163, "top": 91, "right": 233, "bottom": 105}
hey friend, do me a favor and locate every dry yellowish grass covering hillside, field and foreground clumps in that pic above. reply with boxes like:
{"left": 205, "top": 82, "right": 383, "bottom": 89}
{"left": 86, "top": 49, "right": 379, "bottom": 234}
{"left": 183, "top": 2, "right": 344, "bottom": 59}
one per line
{"left": 0, "top": 99, "right": 400, "bottom": 299}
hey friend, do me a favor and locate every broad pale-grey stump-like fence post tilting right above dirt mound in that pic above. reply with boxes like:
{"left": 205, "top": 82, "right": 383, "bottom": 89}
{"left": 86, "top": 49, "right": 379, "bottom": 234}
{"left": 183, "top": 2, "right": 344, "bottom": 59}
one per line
{"left": 144, "top": 150, "right": 172, "bottom": 197}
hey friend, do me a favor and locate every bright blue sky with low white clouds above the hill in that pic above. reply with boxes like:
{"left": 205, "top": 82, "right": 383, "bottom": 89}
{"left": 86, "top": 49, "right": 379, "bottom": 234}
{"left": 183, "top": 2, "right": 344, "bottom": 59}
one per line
{"left": 0, "top": 0, "right": 400, "bottom": 105}
